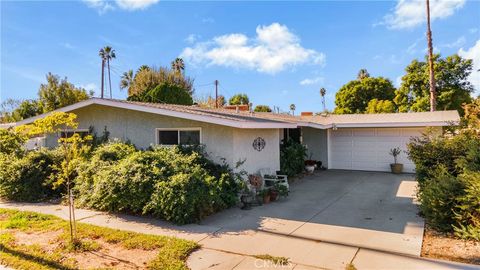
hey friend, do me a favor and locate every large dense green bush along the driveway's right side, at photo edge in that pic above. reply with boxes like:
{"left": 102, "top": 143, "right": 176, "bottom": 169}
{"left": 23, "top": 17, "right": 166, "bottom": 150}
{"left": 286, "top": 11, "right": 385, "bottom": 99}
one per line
{"left": 408, "top": 106, "right": 480, "bottom": 240}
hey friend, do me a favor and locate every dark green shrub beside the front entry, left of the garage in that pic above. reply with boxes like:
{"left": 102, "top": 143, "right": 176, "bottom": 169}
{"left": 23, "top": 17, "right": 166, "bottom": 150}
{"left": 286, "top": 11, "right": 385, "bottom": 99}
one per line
{"left": 280, "top": 140, "right": 307, "bottom": 176}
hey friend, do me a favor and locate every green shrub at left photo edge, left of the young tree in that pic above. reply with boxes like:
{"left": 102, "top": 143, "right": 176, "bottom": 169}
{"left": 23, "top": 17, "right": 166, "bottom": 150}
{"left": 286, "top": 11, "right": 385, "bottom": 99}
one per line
{"left": 0, "top": 149, "right": 62, "bottom": 202}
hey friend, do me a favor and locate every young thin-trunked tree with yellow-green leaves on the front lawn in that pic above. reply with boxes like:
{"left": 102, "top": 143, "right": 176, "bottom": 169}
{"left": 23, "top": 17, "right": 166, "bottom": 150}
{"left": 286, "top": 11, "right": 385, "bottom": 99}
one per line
{"left": 16, "top": 112, "right": 92, "bottom": 247}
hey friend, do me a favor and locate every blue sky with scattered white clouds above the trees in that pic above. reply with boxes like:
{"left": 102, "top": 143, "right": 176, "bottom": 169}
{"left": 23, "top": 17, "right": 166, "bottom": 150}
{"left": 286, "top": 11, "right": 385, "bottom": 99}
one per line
{"left": 0, "top": 0, "right": 480, "bottom": 111}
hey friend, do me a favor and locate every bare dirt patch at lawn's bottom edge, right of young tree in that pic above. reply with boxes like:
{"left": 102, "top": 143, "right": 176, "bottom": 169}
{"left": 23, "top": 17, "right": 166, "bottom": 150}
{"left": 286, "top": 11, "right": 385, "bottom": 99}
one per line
{"left": 68, "top": 240, "right": 158, "bottom": 270}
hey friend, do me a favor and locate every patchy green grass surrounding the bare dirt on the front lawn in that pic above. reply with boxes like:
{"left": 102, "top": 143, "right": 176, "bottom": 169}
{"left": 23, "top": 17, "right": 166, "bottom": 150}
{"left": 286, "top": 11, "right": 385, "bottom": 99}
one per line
{"left": 0, "top": 208, "right": 199, "bottom": 270}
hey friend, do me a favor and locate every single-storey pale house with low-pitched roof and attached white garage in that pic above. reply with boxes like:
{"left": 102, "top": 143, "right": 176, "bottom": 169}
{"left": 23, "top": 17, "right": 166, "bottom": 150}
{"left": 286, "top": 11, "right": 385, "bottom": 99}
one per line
{"left": 6, "top": 98, "right": 460, "bottom": 173}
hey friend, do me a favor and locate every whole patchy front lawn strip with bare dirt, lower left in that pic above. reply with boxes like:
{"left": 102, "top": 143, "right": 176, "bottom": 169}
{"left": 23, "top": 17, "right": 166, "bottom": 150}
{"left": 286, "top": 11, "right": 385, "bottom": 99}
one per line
{"left": 0, "top": 208, "right": 198, "bottom": 269}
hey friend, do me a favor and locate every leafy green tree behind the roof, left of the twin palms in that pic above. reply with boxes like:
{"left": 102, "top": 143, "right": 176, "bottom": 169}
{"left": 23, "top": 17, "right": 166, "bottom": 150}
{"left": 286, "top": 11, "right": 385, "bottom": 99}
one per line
{"left": 38, "top": 73, "right": 93, "bottom": 113}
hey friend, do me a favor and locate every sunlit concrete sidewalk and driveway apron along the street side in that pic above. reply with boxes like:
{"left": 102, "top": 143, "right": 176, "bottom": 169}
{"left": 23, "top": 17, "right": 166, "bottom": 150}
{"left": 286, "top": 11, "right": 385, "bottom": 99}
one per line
{"left": 0, "top": 202, "right": 480, "bottom": 270}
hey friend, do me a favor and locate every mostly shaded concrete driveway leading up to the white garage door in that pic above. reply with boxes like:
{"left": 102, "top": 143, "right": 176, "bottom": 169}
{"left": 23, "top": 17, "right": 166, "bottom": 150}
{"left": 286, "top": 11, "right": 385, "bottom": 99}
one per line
{"left": 198, "top": 170, "right": 424, "bottom": 256}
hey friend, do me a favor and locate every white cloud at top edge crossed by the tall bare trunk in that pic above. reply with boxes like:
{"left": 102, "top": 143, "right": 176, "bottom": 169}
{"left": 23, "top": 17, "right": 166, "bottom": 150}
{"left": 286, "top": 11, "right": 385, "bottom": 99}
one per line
{"left": 381, "top": 0, "right": 466, "bottom": 29}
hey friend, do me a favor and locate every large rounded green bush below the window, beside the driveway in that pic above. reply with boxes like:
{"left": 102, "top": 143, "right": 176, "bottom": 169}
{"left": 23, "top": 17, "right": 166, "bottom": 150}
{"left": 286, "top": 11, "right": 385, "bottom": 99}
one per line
{"left": 75, "top": 142, "right": 239, "bottom": 224}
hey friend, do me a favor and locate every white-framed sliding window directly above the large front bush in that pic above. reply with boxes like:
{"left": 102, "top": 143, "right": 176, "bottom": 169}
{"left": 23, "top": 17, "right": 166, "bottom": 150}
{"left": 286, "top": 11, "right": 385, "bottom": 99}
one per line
{"left": 157, "top": 128, "right": 201, "bottom": 145}
